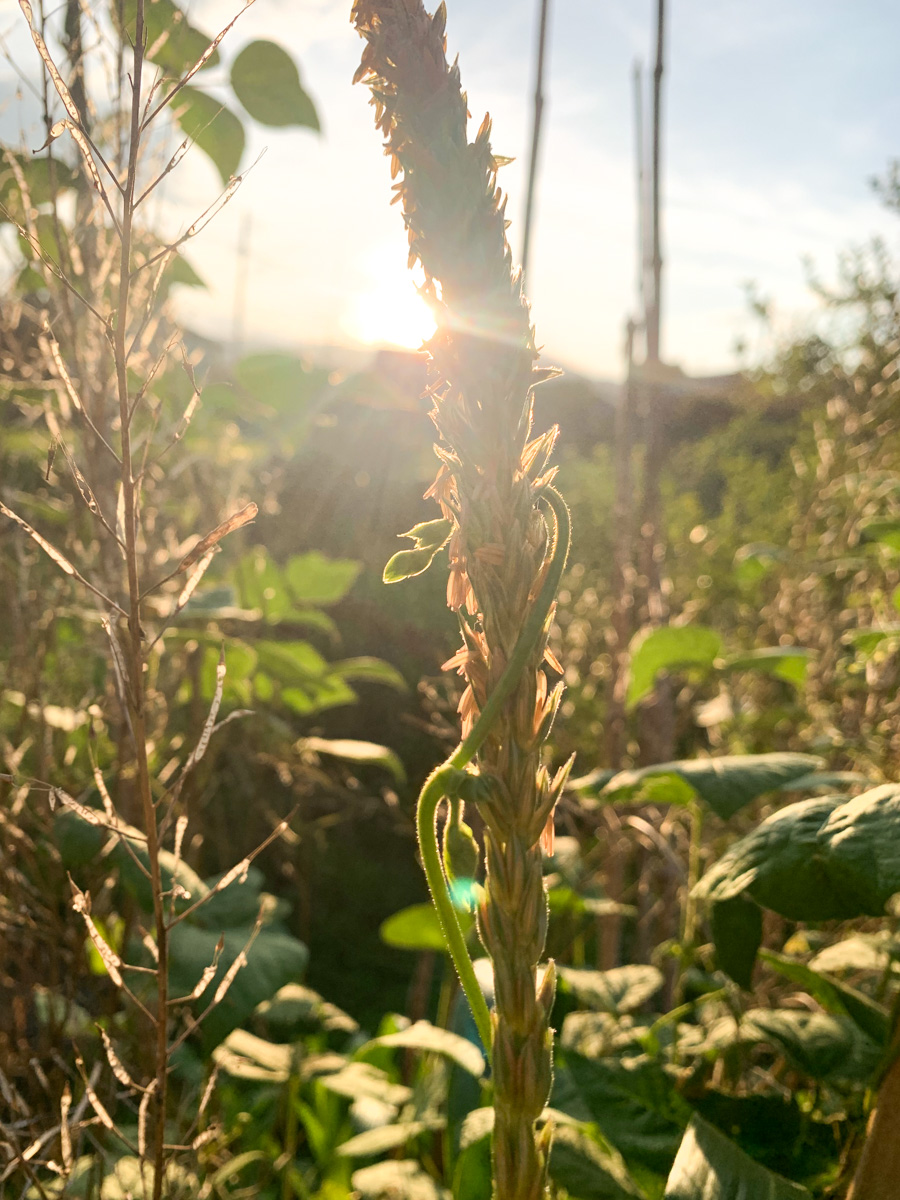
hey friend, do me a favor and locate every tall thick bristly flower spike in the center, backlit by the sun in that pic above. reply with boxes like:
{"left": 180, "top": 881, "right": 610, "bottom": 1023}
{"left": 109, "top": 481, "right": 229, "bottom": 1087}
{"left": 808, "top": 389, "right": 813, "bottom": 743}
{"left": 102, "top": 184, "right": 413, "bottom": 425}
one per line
{"left": 353, "top": 0, "right": 568, "bottom": 1200}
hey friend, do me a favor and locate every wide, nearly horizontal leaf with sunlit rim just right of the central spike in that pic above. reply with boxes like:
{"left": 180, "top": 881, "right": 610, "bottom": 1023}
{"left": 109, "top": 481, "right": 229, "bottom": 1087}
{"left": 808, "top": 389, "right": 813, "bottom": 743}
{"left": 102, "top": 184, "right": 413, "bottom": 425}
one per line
{"left": 604, "top": 751, "right": 821, "bottom": 821}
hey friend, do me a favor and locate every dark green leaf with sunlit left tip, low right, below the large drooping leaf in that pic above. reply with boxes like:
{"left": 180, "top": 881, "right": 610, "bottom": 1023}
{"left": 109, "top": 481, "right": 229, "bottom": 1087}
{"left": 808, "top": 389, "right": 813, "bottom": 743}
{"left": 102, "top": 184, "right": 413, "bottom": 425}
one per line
{"left": 707, "top": 1008, "right": 880, "bottom": 1084}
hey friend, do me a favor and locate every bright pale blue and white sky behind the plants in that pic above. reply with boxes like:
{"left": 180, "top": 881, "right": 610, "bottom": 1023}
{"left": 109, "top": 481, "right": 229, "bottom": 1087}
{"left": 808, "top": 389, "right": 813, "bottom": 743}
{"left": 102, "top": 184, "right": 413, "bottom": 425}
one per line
{"left": 0, "top": 0, "right": 900, "bottom": 378}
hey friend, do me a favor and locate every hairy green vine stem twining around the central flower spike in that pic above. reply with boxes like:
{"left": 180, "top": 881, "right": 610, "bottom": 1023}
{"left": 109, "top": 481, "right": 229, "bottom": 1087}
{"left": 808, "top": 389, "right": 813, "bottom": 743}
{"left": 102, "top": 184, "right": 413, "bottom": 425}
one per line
{"left": 416, "top": 487, "right": 571, "bottom": 1057}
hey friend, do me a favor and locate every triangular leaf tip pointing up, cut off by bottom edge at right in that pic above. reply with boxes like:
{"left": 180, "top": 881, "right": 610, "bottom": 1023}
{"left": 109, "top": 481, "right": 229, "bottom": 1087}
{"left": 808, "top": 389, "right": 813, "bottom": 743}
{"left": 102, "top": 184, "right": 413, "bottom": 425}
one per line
{"left": 665, "top": 1115, "right": 811, "bottom": 1200}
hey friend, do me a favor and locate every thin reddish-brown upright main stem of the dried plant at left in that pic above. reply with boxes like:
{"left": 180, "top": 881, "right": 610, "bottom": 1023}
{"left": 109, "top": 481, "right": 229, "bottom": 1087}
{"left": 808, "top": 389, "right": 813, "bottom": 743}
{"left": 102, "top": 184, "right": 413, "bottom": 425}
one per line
{"left": 113, "top": 0, "right": 169, "bottom": 1200}
